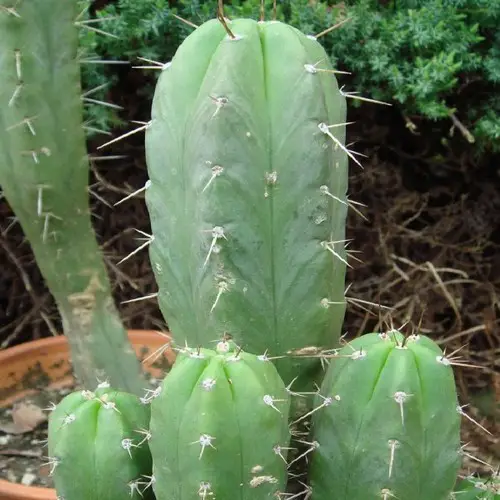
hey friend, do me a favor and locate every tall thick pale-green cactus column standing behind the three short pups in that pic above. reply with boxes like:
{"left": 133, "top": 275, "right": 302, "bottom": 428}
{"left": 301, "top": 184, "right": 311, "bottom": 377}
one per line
{"left": 146, "top": 19, "right": 352, "bottom": 387}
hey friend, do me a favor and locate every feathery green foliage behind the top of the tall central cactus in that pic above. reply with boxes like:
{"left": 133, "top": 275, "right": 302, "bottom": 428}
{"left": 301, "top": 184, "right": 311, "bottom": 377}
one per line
{"left": 82, "top": 0, "right": 500, "bottom": 153}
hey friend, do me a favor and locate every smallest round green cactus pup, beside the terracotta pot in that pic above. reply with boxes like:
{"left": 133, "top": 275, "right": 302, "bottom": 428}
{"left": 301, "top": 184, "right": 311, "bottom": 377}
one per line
{"left": 48, "top": 383, "right": 153, "bottom": 500}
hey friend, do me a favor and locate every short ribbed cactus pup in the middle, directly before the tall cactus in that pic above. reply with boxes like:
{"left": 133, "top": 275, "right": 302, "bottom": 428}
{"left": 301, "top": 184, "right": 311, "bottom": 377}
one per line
{"left": 149, "top": 342, "right": 290, "bottom": 500}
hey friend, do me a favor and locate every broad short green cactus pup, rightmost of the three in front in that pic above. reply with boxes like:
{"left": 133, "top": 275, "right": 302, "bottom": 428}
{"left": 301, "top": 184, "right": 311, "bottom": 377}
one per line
{"left": 309, "top": 331, "right": 461, "bottom": 500}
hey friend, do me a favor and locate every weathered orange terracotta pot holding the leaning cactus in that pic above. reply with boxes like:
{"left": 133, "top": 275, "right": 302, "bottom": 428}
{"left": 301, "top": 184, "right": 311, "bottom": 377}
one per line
{"left": 0, "top": 330, "right": 175, "bottom": 500}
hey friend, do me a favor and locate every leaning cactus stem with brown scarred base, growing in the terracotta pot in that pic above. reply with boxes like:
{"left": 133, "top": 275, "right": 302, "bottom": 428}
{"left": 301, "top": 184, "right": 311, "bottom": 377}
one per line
{"left": 0, "top": 0, "right": 144, "bottom": 393}
